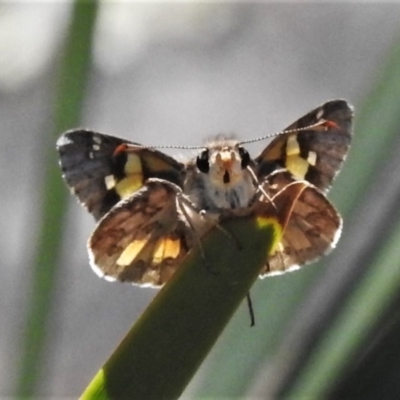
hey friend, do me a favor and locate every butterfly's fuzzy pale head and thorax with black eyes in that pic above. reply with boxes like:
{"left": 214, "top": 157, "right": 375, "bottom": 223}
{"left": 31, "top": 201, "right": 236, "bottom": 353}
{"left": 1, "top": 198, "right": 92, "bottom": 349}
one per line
{"left": 183, "top": 141, "right": 255, "bottom": 211}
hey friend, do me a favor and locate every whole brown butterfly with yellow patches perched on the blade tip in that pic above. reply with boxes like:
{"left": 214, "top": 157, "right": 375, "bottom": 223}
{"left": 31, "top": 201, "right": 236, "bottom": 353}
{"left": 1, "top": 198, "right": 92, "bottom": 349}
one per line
{"left": 57, "top": 100, "right": 353, "bottom": 287}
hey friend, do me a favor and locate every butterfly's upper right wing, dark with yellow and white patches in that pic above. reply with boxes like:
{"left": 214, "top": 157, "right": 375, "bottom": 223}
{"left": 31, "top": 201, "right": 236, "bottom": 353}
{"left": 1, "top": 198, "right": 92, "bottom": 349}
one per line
{"left": 255, "top": 100, "right": 353, "bottom": 191}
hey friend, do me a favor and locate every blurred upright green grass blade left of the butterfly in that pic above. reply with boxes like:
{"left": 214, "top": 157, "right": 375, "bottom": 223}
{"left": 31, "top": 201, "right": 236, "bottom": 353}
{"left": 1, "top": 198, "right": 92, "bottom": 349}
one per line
{"left": 16, "top": 1, "right": 97, "bottom": 398}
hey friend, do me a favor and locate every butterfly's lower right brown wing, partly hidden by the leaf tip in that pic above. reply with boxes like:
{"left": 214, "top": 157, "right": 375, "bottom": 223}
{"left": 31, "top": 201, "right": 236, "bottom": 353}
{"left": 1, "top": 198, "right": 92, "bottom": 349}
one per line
{"left": 261, "top": 172, "right": 342, "bottom": 277}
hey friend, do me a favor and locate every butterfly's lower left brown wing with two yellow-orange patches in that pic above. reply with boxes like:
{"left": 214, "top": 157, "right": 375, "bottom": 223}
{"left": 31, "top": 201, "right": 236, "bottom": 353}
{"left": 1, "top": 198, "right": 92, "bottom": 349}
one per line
{"left": 88, "top": 179, "right": 192, "bottom": 286}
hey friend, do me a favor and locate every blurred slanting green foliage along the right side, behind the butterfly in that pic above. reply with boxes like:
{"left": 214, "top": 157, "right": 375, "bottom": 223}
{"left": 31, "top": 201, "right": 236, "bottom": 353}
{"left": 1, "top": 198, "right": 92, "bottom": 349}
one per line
{"left": 194, "top": 33, "right": 400, "bottom": 400}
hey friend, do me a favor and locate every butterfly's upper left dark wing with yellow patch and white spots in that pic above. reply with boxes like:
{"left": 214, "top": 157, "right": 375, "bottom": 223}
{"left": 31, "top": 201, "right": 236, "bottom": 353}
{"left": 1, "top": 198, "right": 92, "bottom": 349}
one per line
{"left": 57, "top": 130, "right": 184, "bottom": 220}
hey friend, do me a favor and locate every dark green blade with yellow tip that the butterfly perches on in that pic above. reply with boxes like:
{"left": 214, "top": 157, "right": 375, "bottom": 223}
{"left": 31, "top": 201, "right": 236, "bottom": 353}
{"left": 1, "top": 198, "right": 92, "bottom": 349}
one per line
{"left": 81, "top": 218, "right": 281, "bottom": 400}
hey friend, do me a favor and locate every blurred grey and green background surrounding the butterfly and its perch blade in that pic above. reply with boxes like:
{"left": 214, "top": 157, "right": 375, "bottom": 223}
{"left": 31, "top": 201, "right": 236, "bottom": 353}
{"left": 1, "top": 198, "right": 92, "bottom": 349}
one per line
{"left": 0, "top": 1, "right": 400, "bottom": 399}
